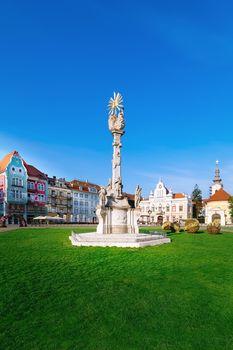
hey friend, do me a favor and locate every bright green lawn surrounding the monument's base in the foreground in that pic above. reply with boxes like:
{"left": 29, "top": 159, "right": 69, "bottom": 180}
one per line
{"left": 0, "top": 228, "right": 233, "bottom": 350}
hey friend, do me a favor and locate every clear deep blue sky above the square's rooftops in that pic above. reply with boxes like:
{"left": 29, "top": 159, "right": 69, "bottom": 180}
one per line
{"left": 0, "top": 0, "right": 233, "bottom": 196}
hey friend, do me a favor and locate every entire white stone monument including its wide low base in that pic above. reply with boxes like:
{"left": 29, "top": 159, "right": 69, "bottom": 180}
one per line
{"left": 70, "top": 93, "right": 170, "bottom": 247}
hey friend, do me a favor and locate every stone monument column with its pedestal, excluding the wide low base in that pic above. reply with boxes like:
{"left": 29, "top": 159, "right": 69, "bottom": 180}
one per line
{"left": 96, "top": 93, "right": 140, "bottom": 234}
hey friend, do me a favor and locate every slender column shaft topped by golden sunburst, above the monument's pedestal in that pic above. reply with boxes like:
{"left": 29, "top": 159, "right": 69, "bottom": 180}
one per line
{"left": 108, "top": 92, "right": 125, "bottom": 198}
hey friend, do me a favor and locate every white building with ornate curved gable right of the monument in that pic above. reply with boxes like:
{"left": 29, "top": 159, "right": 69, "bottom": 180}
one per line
{"left": 140, "top": 180, "right": 192, "bottom": 224}
